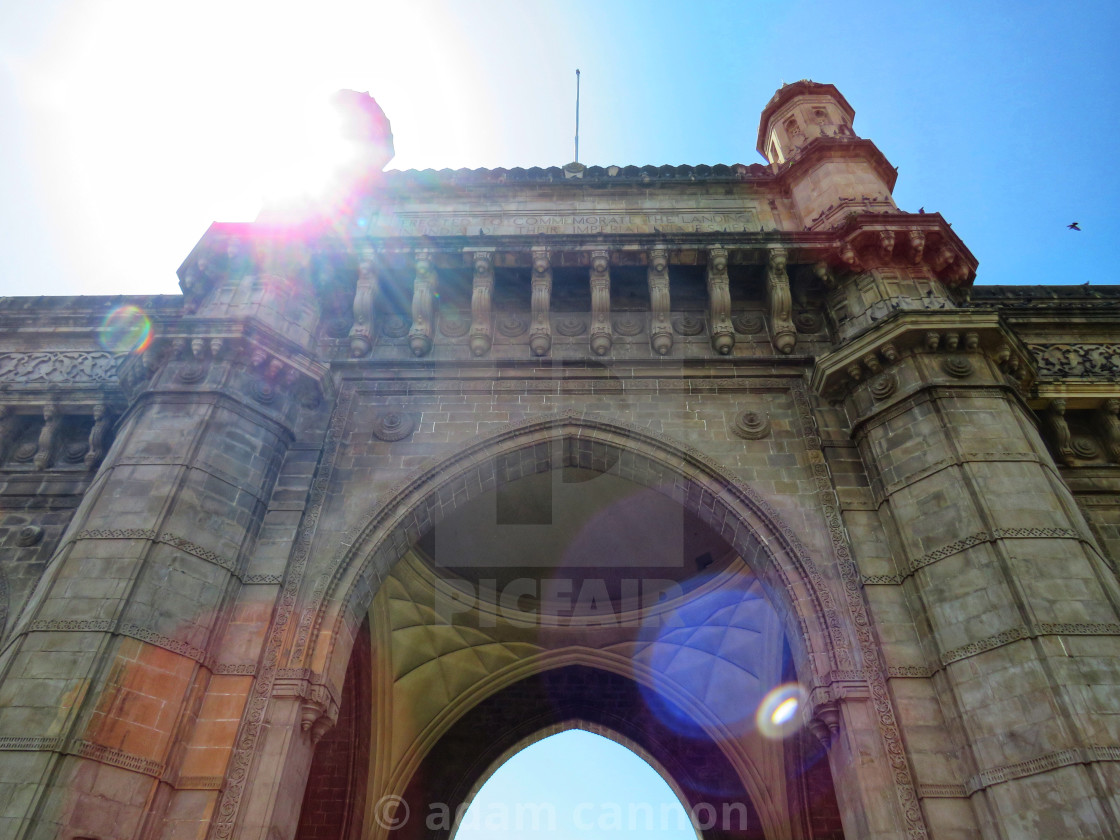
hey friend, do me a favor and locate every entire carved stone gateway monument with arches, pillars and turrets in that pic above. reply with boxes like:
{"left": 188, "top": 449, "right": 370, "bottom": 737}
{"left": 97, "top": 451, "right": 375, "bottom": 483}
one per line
{"left": 0, "top": 82, "right": 1120, "bottom": 840}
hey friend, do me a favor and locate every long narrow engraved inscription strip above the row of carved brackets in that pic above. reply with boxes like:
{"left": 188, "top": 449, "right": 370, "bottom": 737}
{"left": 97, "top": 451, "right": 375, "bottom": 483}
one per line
{"left": 368, "top": 211, "right": 758, "bottom": 236}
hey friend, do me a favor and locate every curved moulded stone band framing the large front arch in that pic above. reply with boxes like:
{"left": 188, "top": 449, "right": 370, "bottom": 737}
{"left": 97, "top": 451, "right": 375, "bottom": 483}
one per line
{"left": 289, "top": 412, "right": 859, "bottom": 687}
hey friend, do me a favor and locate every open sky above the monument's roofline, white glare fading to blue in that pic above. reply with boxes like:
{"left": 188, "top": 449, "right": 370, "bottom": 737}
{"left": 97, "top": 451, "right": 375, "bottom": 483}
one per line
{"left": 0, "top": 0, "right": 1120, "bottom": 295}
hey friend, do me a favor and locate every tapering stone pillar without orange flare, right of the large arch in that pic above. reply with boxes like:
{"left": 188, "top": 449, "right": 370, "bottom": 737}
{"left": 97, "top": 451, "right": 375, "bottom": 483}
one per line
{"left": 814, "top": 310, "right": 1120, "bottom": 840}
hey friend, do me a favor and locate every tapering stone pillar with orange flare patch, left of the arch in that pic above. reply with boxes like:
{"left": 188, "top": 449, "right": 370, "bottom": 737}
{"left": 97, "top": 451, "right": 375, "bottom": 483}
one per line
{"left": 0, "top": 246, "right": 326, "bottom": 840}
